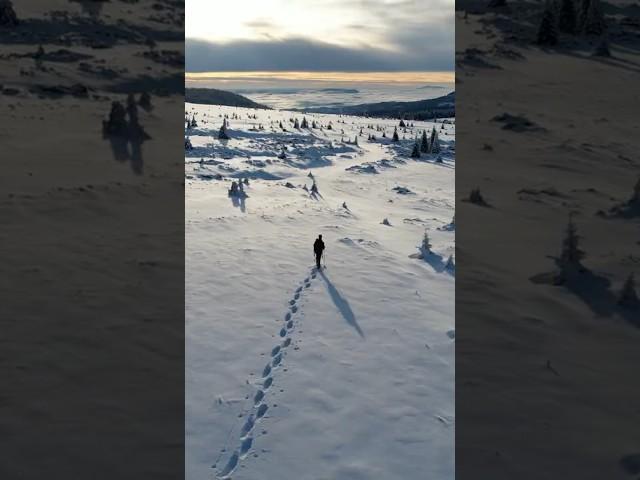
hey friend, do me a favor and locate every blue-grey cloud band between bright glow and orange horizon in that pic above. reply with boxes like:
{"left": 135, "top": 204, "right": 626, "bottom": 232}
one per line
{"left": 185, "top": 36, "right": 454, "bottom": 72}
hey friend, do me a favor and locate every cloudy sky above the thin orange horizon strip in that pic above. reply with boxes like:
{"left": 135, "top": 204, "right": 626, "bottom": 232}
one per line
{"left": 186, "top": 0, "right": 455, "bottom": 77}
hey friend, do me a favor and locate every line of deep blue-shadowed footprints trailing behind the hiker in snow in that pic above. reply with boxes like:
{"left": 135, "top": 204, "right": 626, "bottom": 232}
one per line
{"left": 214, "top": 271, "right": 316, "bottom": 479}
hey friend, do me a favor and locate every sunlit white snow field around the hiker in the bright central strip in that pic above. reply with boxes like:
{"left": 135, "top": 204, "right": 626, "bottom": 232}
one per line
{"left": 185, "top": 104, "right": 455, "bottom": 480}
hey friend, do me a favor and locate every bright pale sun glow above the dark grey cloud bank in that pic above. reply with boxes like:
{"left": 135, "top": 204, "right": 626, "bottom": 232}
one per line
{"left": 185, "top": 0, "right": 454, "bottom": 51}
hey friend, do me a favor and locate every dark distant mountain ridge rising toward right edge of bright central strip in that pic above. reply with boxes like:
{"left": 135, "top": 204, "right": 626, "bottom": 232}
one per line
{"left": 298, "top": 92, "right": 456, "bottom": 120}
